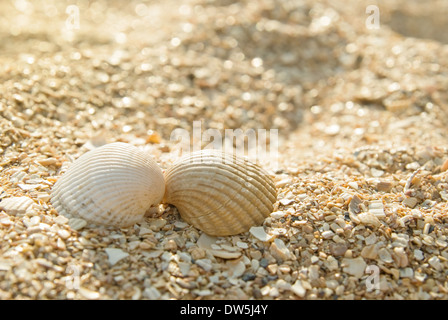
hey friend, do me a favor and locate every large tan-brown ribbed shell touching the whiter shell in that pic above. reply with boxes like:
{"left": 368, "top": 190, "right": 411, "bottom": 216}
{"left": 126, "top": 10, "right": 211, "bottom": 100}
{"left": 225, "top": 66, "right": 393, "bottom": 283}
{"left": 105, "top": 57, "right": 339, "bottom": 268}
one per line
{"left": 164, "top": 150, "right": 277, "bottom": 236}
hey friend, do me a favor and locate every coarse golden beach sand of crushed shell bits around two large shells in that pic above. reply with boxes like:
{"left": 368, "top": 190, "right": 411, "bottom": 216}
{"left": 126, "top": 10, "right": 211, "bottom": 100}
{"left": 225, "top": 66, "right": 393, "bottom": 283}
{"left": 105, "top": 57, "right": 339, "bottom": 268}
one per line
{"left": 0, "top": 0, "right": 448, "bottom": 300}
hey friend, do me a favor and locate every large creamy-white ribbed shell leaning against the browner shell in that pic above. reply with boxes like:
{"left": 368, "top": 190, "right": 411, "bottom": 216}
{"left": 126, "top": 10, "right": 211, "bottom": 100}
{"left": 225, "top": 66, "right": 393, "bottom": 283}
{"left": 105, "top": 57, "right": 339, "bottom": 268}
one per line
{"left": 51, "top": 142, "right": 165, "bottom": 227}
